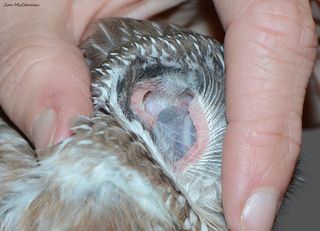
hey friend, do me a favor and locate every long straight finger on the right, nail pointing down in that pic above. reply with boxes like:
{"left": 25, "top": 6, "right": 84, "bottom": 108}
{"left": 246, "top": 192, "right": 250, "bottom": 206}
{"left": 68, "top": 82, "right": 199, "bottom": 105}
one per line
{"left": 215, "top": 0, "right": 316, "bottom": 230}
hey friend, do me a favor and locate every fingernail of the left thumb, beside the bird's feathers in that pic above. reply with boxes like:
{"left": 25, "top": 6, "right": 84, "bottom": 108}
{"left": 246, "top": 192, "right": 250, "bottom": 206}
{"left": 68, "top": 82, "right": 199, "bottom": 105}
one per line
{"left": 31, "top": 109, "right": 57, "bottom": 148}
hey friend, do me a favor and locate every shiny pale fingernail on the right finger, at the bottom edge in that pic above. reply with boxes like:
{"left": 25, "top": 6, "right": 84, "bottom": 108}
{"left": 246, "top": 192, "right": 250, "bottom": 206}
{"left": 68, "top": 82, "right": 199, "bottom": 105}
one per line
{"left": 241, "top": 188, "right": 279, "bottom": 231}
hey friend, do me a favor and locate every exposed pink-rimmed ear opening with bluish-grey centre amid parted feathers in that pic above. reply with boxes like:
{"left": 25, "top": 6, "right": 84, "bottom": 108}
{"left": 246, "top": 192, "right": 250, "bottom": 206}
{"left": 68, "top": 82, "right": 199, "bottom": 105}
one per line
{"left": 131, "top": 83, "right": 209, "bottom": 170}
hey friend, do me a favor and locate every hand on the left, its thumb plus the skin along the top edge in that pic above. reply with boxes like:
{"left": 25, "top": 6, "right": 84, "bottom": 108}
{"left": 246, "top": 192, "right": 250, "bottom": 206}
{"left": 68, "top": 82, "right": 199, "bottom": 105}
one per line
{"left": 0, "top": 0, "right": 181, "bottom": 148}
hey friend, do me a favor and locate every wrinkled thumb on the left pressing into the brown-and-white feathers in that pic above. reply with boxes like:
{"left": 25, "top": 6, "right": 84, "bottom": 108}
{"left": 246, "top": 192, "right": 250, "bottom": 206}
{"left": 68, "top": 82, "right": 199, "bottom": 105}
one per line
{"left": 0, "top": 4, "right": 91, "bottom": 148}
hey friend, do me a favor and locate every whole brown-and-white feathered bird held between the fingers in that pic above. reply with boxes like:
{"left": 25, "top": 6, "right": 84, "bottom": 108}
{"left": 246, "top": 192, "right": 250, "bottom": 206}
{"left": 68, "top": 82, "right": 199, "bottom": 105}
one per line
{"left": 0, "top": 18, "right": 228, "bottom": 231}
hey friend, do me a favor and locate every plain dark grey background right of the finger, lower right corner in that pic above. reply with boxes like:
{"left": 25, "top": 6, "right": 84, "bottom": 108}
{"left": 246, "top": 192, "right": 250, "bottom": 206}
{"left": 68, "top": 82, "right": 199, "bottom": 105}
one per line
{"left": 275, "top": 129, "right": 320, "bottom": 231}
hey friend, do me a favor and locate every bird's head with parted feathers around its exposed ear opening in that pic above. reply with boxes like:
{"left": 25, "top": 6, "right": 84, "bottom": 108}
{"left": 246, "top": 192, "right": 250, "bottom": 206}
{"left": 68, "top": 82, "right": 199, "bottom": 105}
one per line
{"left": 83, "top": 19, "right": 226, "bottom": 229}
